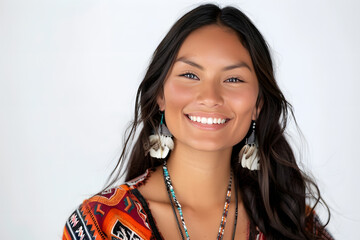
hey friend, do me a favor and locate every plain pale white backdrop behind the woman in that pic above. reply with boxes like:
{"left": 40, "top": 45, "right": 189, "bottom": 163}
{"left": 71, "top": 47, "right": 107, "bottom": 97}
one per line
{"left": 0, "top": 0, "right": 360, "bottom": 239}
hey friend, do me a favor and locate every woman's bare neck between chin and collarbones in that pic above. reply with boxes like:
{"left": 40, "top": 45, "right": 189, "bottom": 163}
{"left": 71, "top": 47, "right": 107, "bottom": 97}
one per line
{"left": 167, "top": 144, "right": 231, "bottom": 207}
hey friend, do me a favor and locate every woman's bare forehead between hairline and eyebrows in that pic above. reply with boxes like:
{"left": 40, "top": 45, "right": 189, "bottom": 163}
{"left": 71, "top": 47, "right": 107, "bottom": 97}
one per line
{"left": 177, "top": 24, "right": 252, "bottom": 66}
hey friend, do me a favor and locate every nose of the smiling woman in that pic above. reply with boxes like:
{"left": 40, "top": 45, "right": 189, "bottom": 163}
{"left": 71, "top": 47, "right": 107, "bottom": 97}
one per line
{"left": 197, "top": 81, "right": 224, "bottom": 108}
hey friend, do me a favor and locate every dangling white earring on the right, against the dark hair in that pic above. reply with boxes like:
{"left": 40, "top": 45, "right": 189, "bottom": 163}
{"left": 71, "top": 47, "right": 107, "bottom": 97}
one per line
{"left": 239, "top": 122, "right": 260, "bottom": 171}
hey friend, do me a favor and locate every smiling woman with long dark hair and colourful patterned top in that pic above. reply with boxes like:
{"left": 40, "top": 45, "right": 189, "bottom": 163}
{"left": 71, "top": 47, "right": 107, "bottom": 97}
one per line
{"left": 63, "top": 4, "right": 332, "bottom": 239}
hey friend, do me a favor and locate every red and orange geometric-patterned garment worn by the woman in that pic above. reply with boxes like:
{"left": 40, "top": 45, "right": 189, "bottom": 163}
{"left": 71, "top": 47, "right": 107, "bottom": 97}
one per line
{"left": 63, "top": 170, "right": 333, "bottom": 240}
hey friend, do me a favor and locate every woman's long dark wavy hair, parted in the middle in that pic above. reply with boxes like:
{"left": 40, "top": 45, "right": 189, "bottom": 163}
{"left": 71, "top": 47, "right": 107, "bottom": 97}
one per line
{"left": 108, "top": 4, "right": 330, "bottom": 239}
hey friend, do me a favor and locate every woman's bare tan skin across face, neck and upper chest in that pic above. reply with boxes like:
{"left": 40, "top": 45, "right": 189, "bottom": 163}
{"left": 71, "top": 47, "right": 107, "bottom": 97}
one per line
{"left": 139, "top": 25, "right": 259, "bottom": 240}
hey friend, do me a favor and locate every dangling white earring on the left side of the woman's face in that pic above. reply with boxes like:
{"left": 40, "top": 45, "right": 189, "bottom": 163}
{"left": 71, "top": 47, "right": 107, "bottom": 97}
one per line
{"left": 149, "top": 112, "right": 174, "bottom": 159}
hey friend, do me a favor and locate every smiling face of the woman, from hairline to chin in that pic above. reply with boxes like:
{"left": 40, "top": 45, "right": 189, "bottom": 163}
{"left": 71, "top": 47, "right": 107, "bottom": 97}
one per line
{"left": 158, "top": 25, "right": 259, "bottom": 151}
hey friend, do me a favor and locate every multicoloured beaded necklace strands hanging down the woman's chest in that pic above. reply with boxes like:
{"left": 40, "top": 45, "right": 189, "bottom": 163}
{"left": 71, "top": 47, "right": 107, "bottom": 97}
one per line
{"left": 163, "top": 161, "right": 238, "bottom": 240}
